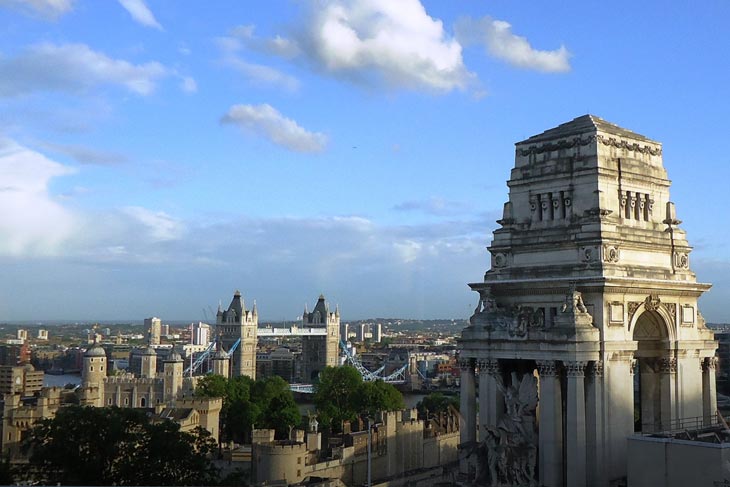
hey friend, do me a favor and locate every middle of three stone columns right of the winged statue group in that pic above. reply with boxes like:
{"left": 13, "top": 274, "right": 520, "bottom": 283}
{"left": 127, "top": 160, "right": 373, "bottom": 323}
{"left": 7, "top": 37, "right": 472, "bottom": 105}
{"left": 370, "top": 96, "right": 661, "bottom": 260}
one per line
{"left": 564, "top": 362, "right": 586, "bottom": 487}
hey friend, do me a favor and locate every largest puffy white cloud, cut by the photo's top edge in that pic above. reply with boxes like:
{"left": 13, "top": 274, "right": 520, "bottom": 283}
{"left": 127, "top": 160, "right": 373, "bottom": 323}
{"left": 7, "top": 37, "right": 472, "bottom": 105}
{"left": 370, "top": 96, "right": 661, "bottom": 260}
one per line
{"left": 302, "top": 0, "right": 475, "bottom": 92}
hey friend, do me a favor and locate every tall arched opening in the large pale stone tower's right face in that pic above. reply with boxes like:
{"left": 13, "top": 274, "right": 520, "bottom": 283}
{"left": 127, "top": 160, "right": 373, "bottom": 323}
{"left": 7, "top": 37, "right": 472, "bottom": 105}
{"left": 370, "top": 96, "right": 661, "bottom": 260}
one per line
{"left": 633, "top": 311, "right": 673, "bottom": 433}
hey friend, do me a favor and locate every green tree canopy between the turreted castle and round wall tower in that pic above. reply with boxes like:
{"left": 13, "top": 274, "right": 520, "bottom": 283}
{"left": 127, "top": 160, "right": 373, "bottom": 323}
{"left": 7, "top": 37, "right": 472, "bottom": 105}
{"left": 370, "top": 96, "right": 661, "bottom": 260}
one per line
{"left": 195, "top": 374, "right": 301, "bottom": 443}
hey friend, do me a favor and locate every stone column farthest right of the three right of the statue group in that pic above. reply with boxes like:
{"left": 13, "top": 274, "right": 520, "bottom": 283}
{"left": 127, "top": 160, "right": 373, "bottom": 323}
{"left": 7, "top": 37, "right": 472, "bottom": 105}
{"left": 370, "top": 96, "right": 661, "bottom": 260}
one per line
{"left": 586, "top": 360, "right": 608, "bottom": 487}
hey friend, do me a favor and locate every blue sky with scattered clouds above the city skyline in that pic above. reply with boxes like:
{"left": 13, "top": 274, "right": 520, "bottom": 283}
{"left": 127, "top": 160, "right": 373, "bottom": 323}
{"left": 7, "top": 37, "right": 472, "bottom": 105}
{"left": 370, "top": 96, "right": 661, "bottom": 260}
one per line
{"left": 0, "top": 0, "right": 730, "bottom": 321}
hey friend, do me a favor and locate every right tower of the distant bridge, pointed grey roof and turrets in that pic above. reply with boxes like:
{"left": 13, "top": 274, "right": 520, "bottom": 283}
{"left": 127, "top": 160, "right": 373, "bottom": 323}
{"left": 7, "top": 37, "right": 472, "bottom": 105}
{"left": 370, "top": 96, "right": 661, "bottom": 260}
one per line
{"left": 302, "top": 294, "right": 340, "bottom": 381}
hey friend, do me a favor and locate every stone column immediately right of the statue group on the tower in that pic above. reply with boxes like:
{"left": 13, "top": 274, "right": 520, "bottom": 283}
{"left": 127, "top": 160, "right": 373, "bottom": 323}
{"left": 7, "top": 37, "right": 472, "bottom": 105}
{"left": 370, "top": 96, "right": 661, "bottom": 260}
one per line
{"left": 537, "top": 360, "right": 563, "bottom": 487}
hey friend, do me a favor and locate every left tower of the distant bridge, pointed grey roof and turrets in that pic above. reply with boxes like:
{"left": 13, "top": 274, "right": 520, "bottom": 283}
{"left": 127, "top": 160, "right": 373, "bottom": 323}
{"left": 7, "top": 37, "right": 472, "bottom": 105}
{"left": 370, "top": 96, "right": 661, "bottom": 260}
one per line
{"left": 216, "top": 290, "right": 259, "bottom": 379}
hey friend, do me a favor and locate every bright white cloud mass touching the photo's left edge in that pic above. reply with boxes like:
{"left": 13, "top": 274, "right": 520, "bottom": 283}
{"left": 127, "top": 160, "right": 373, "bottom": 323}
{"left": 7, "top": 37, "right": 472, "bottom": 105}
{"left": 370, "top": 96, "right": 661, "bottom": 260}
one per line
{"left": 0, "top": 138, "right": 77, "bottom": 256}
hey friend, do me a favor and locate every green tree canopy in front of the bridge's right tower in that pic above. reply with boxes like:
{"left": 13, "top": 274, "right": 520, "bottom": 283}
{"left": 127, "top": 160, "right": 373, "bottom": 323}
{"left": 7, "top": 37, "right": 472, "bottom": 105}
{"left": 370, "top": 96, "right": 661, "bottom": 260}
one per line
{"left": 313, "top": 365, "right": 405, "bottom": 432}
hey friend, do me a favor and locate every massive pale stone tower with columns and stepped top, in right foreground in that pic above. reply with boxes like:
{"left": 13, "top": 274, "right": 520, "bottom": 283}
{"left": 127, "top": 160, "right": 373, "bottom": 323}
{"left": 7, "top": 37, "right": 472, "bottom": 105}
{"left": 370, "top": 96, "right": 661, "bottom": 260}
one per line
{"left": 460, "top": 115, "right": 716, "bottom": 487}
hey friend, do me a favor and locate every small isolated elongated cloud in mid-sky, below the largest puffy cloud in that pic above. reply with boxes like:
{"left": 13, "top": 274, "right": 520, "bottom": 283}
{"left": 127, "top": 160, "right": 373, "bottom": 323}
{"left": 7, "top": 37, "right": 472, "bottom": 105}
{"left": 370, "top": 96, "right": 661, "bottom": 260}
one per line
{"left": 221, "top": 104, "right": 327, "bottom": 152}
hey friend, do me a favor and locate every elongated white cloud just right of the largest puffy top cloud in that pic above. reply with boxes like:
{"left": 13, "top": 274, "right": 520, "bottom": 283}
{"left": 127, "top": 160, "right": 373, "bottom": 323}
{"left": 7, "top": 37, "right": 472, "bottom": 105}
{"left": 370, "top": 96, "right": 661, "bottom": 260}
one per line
{"left": 456, "top": 17, "right": 570, "bottom": 73}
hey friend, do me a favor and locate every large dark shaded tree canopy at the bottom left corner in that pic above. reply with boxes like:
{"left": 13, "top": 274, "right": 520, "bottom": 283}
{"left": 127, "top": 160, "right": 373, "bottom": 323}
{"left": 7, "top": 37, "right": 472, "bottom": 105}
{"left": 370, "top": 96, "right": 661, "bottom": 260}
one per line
{"left": 24, "top": 406, "right": 217, "bottom": 485}
